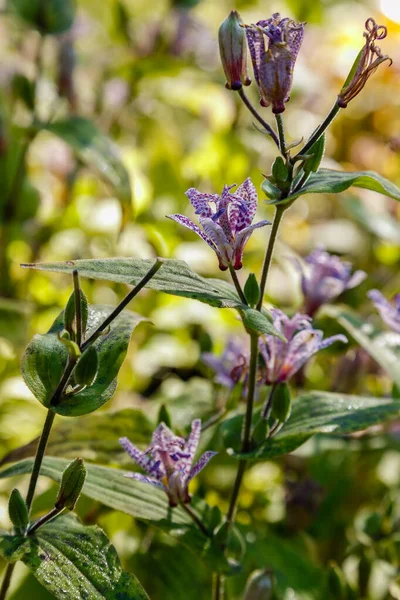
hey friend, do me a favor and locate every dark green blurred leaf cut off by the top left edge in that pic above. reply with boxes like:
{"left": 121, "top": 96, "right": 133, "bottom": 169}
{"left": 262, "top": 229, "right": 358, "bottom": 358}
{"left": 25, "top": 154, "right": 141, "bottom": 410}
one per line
{"left": 8, "top": 0, "right": 75, "bottom": 34}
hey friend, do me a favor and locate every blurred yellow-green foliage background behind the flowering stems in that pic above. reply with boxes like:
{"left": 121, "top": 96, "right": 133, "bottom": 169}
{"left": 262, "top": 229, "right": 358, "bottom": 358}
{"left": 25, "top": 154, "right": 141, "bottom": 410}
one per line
{"left": 0, "top": 0, "right": 400, "bottom": 600}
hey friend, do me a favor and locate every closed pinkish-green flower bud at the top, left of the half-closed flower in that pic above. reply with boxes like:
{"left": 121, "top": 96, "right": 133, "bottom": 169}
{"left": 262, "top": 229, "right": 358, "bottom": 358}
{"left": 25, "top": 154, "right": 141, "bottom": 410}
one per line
{"left": 218, "top": 10, "right": 251, "bottom": 90}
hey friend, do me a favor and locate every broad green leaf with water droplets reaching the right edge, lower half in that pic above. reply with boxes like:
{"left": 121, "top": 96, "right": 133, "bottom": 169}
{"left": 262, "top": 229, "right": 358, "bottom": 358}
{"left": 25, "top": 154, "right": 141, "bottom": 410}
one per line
{"left": 233, "top": 391, "right": 400, "bottom": 460}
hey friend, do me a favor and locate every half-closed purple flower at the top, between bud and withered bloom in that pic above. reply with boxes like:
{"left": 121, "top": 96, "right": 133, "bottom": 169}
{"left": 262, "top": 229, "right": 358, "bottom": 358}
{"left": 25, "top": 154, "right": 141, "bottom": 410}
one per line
{"left": 246, "top": 13, "right": 305, "bottom": 114}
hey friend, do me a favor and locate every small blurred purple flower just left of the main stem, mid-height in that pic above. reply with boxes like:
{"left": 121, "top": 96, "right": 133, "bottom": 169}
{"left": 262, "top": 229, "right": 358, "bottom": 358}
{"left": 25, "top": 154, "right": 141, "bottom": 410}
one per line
{"left": 201, "top": 338, "right": 249, "bottom": 389}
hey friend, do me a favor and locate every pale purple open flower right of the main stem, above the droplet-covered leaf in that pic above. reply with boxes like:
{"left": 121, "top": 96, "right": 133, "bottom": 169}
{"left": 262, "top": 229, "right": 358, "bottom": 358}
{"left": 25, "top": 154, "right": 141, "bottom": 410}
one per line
{"left": 259, "top": 308, "right": 347, "bottom": 384}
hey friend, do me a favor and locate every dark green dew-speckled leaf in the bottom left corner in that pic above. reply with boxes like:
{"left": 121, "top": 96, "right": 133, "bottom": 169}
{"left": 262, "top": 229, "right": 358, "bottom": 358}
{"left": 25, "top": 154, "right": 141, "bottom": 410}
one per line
{"left": 0, "top": 515, "right": 148, "bottom": 600}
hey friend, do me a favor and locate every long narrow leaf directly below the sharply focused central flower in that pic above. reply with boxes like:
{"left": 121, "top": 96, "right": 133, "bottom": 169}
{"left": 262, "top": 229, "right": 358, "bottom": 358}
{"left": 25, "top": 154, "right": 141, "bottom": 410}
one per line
{"left": 22, "top": 258, "right": 278, "bottom": 335}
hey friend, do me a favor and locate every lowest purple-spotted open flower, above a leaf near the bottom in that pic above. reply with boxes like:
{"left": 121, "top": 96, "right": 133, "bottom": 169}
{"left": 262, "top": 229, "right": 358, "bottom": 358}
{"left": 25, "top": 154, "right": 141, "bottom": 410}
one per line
{"left": 119, "top": 419, "right": 217, "bottom": 506}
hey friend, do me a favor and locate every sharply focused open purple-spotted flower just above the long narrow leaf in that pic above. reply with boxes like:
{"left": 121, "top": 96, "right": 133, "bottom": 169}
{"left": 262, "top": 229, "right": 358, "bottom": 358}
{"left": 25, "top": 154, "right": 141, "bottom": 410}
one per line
{"left": 168, "top": 178, "right": 270, "bottom": 271}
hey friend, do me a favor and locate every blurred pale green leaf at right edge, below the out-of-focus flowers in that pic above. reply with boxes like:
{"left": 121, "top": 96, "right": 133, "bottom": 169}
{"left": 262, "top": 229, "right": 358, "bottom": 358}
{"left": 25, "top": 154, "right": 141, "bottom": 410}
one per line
{"left": 322, "top": 306, "right": 400, "bottom": 387}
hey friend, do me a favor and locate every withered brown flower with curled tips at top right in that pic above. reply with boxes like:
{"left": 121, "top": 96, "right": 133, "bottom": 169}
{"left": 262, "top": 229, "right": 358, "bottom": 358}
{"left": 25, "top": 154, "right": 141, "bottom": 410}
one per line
{"left": 337, "top": 18, "right": 392, "bottom": 108}
